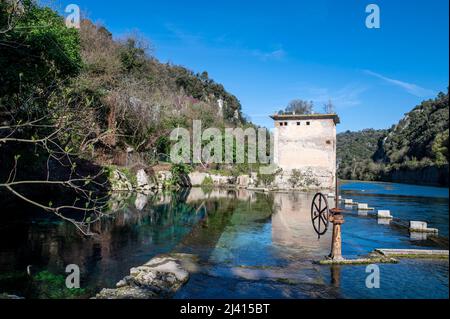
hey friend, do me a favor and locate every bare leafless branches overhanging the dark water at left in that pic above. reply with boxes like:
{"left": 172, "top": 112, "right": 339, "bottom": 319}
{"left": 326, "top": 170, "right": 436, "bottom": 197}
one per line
{"left": 0, "top": 91, "right": 108, "bottom": 235}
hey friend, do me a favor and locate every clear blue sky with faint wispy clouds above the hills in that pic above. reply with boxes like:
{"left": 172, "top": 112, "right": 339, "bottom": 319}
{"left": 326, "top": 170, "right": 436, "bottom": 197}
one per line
{"left": 54, "top": 0, "right": 449, "bottom": 131}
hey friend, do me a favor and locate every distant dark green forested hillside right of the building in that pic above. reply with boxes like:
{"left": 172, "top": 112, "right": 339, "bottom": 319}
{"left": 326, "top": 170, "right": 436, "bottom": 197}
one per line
{"left": 338, "top": 92, "right": 449, "bottom": 184}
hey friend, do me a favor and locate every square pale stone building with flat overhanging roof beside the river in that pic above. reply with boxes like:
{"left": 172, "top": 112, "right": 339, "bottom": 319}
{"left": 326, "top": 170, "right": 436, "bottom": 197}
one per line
{"left": 271, "top": 114, "right": 340, "bottom": 189}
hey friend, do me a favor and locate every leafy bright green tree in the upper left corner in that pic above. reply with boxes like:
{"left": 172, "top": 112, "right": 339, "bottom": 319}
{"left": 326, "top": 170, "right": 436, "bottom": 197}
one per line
{"left": 0, "top": 0, "right": 82, "bottom": 100}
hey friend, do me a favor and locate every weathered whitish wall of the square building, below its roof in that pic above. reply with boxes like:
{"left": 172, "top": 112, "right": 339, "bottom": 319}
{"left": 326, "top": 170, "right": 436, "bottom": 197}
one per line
{"left": 274, "top": 119, "right": 336, "bottom": 189}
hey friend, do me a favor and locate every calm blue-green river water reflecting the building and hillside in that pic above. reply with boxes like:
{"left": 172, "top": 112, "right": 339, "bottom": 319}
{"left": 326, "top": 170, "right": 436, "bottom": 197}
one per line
{"left": 0, "top": 182, "right": 449, "bottom": 298}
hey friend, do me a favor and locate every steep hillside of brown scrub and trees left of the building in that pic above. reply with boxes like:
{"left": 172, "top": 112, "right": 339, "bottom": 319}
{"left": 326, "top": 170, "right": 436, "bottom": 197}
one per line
{"left": 0, "top": 0, "right": 252, "bottom": 230}
